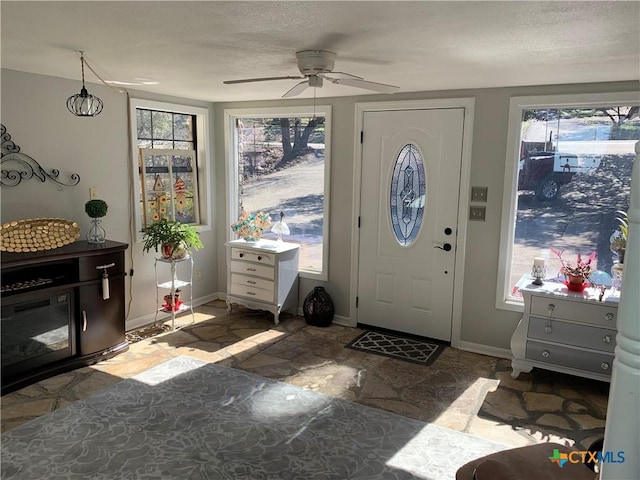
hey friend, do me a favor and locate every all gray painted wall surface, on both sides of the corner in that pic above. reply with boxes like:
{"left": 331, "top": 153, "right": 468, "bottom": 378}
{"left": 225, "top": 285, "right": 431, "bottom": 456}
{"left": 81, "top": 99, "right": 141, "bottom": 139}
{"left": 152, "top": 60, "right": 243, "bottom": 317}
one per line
{"left": 1, "top": 70, "right": 638, "bottom": 349}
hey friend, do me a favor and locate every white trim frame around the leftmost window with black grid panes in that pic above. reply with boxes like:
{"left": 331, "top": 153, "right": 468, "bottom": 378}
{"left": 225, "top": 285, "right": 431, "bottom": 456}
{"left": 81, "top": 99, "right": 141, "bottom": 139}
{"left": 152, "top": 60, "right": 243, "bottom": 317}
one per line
{"left": 129, "top": 98, "right": 213, "bottom": 242}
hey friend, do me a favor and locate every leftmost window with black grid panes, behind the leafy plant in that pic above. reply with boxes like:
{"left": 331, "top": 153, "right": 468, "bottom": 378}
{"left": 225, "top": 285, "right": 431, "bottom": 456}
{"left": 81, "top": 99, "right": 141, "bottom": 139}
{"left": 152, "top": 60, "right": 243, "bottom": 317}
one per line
{"left": 131, "top": 99, "right": 210, "bottom": 238}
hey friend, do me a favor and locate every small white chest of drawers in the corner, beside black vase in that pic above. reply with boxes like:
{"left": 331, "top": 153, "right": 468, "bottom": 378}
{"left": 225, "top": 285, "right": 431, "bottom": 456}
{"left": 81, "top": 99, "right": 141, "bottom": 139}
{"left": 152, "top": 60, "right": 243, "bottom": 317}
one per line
{"left": 225, "top": 240, "right": 300, "bottom": 325}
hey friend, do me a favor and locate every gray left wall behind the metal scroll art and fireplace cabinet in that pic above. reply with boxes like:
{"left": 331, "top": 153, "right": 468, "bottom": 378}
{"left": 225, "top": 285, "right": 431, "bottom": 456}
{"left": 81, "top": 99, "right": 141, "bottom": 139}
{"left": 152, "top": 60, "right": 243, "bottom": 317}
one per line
{"left": 0, "top": 70, "right": 218, "bottom": 326}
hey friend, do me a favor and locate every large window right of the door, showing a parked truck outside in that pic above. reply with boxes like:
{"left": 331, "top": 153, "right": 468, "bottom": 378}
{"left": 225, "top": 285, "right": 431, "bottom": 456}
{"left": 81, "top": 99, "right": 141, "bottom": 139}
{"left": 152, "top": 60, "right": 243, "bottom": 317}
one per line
{"left": 496, "top": 93, "right": 640, "bottom": 310}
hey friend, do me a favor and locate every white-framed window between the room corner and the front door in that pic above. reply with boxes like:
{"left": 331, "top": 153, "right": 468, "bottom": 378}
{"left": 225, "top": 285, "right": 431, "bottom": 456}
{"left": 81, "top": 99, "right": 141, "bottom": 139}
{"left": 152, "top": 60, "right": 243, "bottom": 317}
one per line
{"left": 225, "top": 106, "right": 331, "bottom": 280}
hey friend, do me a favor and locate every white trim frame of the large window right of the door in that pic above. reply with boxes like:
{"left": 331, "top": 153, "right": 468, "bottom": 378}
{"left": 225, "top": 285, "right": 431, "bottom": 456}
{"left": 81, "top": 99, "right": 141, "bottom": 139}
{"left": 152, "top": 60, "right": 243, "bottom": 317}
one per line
{"left": 496, "top": 92, "right": 639, "bottom": 312}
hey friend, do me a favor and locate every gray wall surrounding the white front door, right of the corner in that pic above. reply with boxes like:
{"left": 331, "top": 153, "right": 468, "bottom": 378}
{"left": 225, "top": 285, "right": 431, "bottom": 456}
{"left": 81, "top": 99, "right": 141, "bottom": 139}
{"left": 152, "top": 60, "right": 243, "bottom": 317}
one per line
{"left": 214, "top": 82, "right": 638, "bottom": 351}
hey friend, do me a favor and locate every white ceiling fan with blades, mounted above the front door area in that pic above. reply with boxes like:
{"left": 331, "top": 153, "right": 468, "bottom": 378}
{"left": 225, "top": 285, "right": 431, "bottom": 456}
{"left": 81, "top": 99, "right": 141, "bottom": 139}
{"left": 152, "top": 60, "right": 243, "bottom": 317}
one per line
{"left": 222, "top": 50, "right": 400, "bottom": 98}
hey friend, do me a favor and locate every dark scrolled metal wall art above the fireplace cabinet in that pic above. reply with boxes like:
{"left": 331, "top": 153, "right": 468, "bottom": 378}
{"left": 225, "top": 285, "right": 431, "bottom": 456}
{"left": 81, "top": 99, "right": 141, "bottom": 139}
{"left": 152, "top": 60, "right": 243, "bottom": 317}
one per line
{"left": 0, "top": 125, "right": 80, "bottom": 187}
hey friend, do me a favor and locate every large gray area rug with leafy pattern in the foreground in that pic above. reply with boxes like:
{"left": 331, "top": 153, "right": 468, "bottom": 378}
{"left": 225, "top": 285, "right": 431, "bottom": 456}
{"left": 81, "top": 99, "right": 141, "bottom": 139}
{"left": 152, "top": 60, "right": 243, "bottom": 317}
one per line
{"left": 1, "top": 357, "right": 507, "bottom": 480}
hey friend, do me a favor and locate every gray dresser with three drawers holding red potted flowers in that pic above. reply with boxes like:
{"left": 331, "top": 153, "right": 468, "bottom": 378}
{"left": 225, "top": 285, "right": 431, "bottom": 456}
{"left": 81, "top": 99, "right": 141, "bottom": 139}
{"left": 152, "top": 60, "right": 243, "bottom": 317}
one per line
{"left": 511, "top": 282, "right": 619, "bottom": 382}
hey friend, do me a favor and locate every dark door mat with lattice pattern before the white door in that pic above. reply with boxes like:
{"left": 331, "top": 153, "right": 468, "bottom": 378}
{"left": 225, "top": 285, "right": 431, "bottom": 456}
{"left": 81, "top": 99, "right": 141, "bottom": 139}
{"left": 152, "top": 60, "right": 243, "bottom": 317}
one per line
{"left": 346, "top": 330, "right": 445, "bottom": 365}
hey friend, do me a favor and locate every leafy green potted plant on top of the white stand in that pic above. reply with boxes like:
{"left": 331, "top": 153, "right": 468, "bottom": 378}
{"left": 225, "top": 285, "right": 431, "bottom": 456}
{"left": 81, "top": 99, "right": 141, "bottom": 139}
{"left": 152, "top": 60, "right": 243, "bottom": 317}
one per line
{"left": 142, "top": 218, "right": 203, "bottom": 259}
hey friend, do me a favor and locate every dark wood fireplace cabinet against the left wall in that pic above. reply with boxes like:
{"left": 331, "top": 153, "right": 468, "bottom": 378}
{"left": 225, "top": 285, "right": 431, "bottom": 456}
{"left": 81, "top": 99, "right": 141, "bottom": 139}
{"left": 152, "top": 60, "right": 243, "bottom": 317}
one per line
{"left": 0, "top": 240, "right": 129, "bottom": 395}
